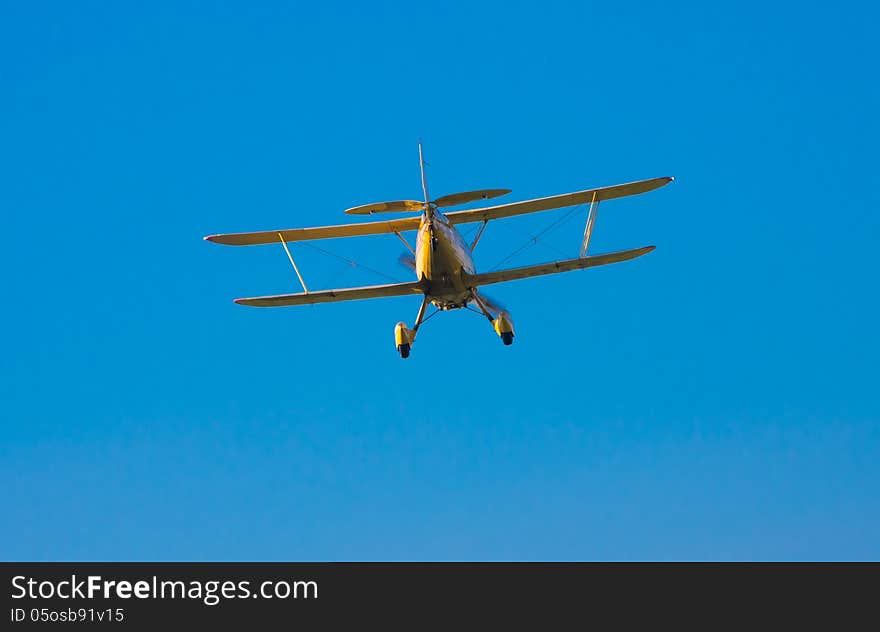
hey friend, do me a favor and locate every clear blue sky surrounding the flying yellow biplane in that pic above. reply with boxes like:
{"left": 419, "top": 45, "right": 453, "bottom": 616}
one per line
{"left": 0, "top": 1, "right": 880, "bottom": 560}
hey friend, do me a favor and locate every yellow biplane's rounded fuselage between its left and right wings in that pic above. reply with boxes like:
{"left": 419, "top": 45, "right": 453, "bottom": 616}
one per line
{"left": 415, "top": 209, "right": 475, "bottom": 309}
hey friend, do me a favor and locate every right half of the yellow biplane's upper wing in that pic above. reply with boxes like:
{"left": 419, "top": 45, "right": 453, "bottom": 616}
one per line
{"left": 446, "top": 177, "right": 675, "bottom": 224}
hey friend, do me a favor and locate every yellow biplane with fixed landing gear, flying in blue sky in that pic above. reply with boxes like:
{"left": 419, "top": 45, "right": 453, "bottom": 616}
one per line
{"left": 205, "top": 142, "right": 674, "bottom": 358}
